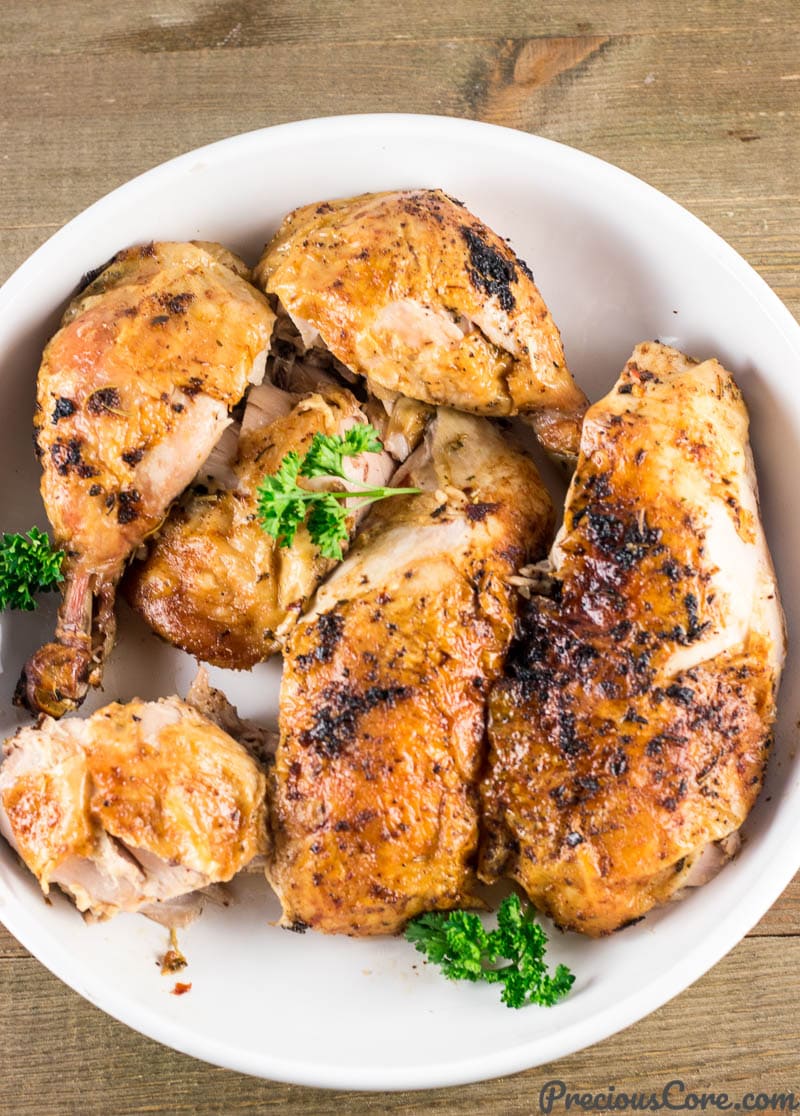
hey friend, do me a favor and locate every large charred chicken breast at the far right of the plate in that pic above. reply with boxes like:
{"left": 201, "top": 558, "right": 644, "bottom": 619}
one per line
{"left": 481, "top": 344, "right": 784, "bottom": 935}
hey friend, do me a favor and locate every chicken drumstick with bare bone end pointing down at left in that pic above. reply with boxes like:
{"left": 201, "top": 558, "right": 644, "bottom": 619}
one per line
{"left": 18, "top": 243, "right": 274, "bottom": 716}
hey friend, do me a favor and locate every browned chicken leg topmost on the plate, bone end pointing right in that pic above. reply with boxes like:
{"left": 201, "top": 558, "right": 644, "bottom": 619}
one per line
{"left": 254, "top": 190, "right": 586, "bottom": 460}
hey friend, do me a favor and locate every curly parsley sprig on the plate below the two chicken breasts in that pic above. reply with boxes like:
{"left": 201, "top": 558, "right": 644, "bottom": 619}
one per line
{"left": 405, "top": 895, "right": 575, "bottom": 1008}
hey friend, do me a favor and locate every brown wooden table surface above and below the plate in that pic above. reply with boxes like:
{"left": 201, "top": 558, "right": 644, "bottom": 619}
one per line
{"left": 0, "top": 0, "right": 800, "bottom": 1116}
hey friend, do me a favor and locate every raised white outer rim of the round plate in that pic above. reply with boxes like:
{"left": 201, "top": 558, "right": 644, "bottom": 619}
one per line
{"left": 0, "top": 113, "right": 800, "bottom": 1090}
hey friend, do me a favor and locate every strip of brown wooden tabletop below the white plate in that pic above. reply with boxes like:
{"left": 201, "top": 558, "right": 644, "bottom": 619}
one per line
{"left": 0, "top": 937, "right": 800, "bottom": 1116}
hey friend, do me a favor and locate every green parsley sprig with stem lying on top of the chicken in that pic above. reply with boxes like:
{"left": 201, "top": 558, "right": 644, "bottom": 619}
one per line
{"left": 258, "top": 423, "right": 420, "bottom": 559}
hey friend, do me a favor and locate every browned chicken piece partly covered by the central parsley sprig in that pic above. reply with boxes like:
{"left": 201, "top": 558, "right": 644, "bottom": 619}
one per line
{"left": 124, "top": 384, "right": 395, "bottom": 670}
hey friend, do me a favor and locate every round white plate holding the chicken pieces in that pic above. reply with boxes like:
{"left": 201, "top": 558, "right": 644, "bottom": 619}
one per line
{"left": 0, "top": 116, "right": 800, "bottom": 1089}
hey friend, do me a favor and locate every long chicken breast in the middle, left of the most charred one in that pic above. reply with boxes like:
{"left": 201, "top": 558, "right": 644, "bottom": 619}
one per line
{"left": 268, "top": 408, "right": 552, "bottom": 935}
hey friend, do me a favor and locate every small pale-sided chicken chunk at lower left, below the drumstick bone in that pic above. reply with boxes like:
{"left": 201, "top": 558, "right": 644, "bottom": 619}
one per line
{"left": 0, "top": 698, "right": 268, "bottom": 921}
